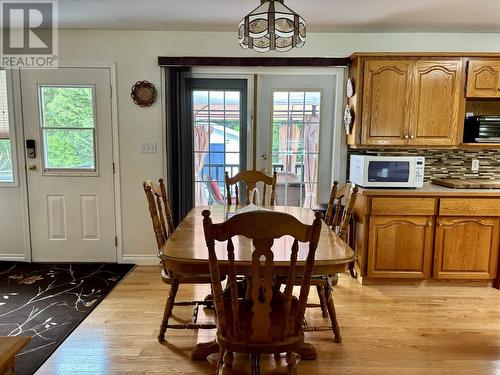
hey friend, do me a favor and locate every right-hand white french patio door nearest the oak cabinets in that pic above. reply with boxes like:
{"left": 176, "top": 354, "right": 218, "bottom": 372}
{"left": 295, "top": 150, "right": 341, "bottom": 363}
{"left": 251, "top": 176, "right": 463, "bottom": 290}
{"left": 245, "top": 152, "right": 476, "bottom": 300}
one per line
{"left": 256, "top": 74, "right": 337, "bottom": 207}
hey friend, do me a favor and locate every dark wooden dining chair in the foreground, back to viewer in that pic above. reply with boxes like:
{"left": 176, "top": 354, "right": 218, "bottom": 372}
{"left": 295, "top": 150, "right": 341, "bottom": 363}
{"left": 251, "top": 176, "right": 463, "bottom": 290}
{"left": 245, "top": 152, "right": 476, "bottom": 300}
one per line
{"left": 202, "top": 210, "right": 323, "bottom": 374}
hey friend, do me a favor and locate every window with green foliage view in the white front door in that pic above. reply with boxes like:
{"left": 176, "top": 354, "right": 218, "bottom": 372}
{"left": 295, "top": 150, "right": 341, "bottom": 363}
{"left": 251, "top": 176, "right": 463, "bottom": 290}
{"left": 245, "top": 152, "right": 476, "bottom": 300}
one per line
{"left": 39, "top": 86, "right": 96, "bottom": 171}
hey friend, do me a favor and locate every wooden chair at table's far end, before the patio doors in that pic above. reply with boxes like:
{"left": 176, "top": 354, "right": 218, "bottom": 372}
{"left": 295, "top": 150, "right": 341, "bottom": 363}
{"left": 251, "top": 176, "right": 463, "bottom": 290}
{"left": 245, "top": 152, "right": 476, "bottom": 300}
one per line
{"left": 224, "top": 171, "right": 276, "bottom": 206}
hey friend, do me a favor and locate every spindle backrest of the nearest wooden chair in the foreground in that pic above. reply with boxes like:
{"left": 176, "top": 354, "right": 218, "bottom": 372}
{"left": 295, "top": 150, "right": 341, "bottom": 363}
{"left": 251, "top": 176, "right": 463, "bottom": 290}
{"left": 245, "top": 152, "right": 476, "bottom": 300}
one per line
{"left": 202, "top": 210, "right": 323, "bottom": 343}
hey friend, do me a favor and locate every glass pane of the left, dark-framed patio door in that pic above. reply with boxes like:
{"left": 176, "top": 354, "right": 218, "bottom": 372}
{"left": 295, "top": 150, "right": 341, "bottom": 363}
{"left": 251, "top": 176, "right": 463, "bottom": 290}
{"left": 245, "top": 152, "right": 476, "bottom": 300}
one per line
{"left": 193, "top": 90, "right": 241, "bottom": 206}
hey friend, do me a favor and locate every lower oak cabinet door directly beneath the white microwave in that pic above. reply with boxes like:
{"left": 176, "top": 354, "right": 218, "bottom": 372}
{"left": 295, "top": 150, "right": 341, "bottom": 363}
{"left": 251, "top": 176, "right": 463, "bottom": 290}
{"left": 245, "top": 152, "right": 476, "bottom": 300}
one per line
{"left": 367, "top": 216, "right": 434, "bottom": 279}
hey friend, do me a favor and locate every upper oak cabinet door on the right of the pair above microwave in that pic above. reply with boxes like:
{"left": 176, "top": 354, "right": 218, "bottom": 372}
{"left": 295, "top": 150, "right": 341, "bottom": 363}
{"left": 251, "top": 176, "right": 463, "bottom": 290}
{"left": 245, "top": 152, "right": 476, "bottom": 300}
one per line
{"left": 410, "top": 60, "right": 465, "bottom": 146}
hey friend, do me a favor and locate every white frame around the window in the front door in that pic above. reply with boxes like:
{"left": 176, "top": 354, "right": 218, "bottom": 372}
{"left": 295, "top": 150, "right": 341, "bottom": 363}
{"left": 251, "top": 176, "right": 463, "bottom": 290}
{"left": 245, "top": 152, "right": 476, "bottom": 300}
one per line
{"left": 37, "top": 83, "right": 100, "bottom": 177}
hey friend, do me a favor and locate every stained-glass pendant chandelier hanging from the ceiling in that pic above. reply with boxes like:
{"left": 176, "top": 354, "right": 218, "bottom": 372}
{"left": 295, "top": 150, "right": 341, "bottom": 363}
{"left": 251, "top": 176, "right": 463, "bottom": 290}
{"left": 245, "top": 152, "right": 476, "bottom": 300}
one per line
{"left": 238, "top": 0, "right": 306, "bottom": 52}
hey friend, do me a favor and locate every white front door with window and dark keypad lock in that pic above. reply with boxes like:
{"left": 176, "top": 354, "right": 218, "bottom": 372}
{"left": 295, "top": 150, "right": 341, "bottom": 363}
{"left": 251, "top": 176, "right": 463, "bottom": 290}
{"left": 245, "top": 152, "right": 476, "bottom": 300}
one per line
{"left": 21, "top": 68, "right": 116, "bottom": 262}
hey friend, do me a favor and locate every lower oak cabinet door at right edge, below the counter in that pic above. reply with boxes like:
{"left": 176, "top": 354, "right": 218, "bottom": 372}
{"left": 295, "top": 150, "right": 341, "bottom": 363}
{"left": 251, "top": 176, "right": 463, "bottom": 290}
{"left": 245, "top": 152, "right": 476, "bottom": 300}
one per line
{"left": 434, "top": 217, "right": 499, "bottom": 280}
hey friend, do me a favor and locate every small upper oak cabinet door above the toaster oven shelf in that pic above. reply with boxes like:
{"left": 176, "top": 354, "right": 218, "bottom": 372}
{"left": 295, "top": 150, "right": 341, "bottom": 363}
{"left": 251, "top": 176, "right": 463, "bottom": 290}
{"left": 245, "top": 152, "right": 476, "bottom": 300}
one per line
{"left": 466, "top": 60, "right": 500, "bottom": 98}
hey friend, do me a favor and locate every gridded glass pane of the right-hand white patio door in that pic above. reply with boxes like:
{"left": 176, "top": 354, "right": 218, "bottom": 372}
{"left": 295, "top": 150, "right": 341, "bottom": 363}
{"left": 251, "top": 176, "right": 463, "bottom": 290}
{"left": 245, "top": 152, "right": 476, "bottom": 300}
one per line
{"left": 272, "top": 91, "right": 321, "bottom": 207}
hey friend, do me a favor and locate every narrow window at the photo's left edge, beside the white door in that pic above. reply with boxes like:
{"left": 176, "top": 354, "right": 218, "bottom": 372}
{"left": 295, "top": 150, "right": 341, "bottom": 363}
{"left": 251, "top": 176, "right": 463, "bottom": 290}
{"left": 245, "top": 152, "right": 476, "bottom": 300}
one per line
{"left": 0, "top": 70, "right": 14, "bottom": 183}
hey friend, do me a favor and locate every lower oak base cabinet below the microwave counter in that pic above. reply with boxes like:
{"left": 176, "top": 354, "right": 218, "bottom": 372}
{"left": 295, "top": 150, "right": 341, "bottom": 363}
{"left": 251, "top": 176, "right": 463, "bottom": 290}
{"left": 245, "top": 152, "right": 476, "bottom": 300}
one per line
{"left": 354, "top": 189, "right": 500, "bottom": 280}
